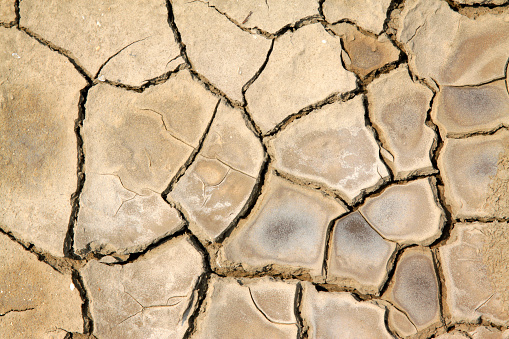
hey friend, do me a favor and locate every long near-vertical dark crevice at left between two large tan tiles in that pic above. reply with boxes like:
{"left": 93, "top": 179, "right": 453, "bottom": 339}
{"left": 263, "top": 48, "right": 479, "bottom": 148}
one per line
{"left": 63, "top": 83, "right": 93, "bottom": 259}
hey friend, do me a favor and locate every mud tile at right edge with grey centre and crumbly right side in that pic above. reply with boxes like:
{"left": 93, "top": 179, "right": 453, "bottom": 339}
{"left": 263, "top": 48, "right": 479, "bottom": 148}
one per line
{"left": 438, "top": 130, "right": 509, "bottom": 218}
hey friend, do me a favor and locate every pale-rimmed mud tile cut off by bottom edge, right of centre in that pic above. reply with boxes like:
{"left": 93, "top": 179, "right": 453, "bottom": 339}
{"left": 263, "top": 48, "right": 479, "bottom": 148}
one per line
{"left": 302, "top": 284, "right": 393, "bottom": 339}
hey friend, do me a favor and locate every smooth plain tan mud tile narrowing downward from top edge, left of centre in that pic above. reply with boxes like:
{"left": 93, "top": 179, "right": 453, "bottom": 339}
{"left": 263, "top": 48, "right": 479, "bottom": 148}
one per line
{"left": 172, "top": 0, "right": 271, "bottom": 101}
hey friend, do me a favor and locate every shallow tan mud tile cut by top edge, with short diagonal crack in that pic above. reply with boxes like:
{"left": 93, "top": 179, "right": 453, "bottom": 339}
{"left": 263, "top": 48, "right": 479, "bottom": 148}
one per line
{"left": 207, "top": 0, "right": 318, "bottom": 33}
